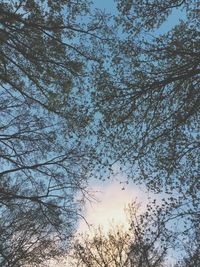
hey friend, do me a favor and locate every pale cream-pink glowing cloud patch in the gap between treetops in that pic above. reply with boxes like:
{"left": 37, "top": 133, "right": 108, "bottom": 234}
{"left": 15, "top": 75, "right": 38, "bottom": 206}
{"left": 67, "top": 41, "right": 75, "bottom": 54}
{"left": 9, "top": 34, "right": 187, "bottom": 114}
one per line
{"left": 78, "top": 177, "right": 150, "bottom": 236}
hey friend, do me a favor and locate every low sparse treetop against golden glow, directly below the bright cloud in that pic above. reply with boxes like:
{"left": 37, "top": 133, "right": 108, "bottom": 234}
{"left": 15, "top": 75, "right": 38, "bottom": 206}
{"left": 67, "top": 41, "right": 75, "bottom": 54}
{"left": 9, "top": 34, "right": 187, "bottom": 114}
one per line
{"left": 70, "top": 228, "right": 130, "bottom": 267}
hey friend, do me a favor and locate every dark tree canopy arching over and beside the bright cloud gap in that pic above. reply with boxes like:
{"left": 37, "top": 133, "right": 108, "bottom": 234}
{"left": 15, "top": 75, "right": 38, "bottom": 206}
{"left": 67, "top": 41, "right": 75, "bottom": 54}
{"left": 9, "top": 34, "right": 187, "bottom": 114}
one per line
{"left": 0, "top": 0, "right": 200, "bottom": 267}
